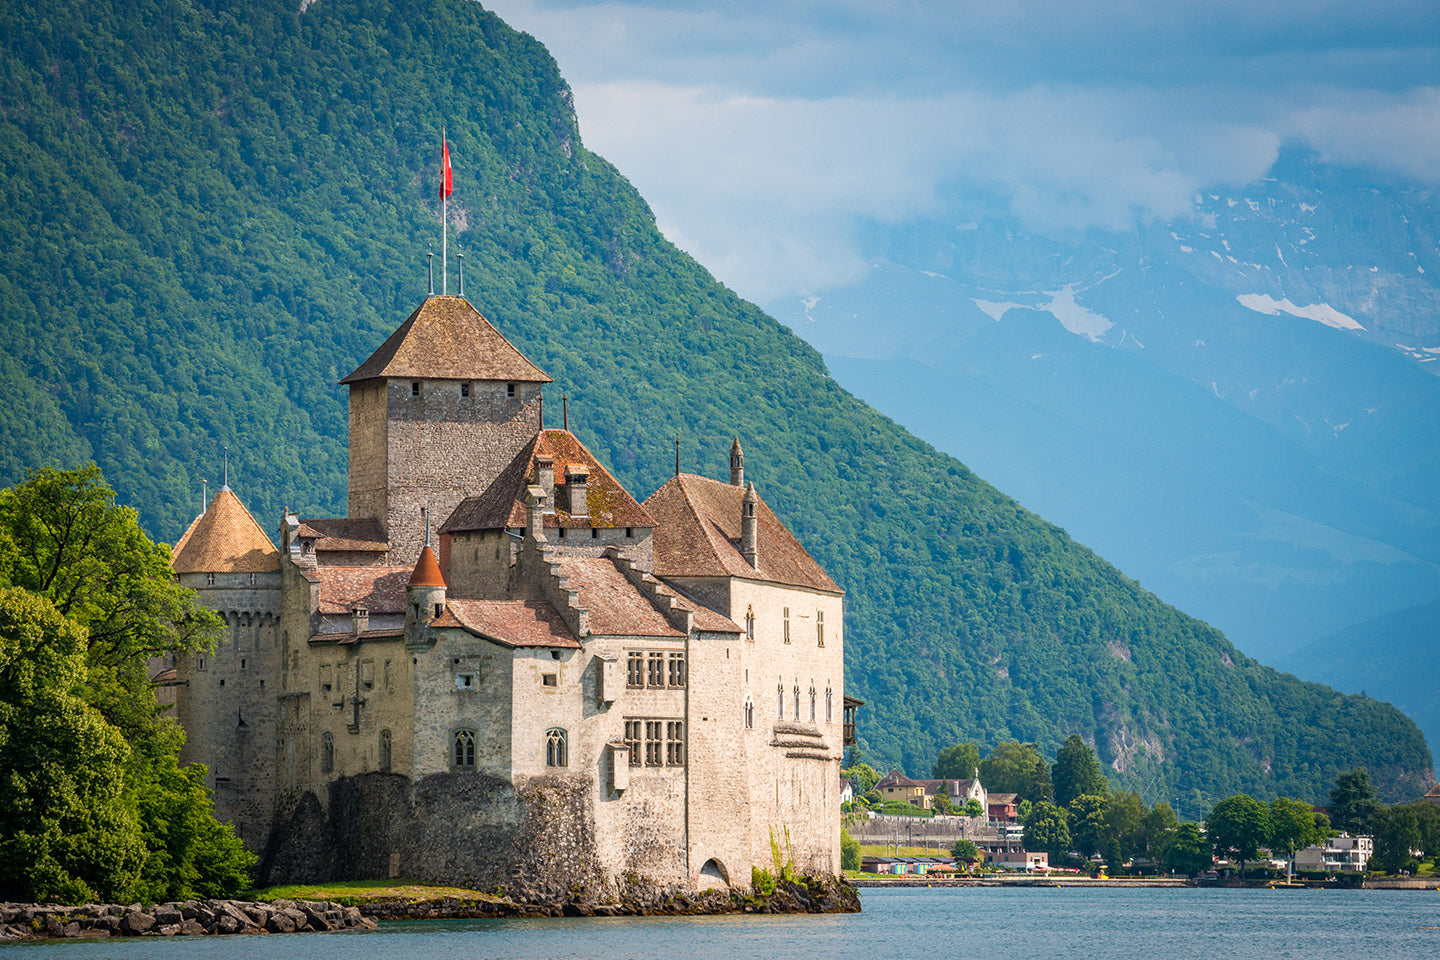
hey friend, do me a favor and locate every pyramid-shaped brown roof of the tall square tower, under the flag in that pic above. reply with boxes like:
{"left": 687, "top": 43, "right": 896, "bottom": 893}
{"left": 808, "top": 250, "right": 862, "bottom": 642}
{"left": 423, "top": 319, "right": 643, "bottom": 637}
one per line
{"left": 340, "top": 296, "right": 550, "bottom": 383}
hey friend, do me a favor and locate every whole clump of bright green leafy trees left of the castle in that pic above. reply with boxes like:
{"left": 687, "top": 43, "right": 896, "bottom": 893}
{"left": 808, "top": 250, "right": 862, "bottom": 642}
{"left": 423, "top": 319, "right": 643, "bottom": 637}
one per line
{"left": 0, "top": 466, "right": 253, "bottom": 901}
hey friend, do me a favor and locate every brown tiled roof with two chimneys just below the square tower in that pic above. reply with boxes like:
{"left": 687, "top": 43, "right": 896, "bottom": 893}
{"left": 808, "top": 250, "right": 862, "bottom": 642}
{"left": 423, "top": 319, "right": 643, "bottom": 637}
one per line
{"left": 441, "top": 430, "right": 655, "bottom": 534}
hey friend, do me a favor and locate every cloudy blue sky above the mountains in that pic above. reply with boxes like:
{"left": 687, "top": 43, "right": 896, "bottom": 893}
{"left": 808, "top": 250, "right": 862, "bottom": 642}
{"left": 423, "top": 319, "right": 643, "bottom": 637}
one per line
{"left": 485, "top": 0, "right": 1440, "bottom": 301}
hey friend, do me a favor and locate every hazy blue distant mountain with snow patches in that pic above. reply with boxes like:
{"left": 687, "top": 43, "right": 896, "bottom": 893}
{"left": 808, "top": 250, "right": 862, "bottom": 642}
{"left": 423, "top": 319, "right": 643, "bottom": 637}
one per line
{"left": 770, "top": 150, "right": 1440, "bottom": 738}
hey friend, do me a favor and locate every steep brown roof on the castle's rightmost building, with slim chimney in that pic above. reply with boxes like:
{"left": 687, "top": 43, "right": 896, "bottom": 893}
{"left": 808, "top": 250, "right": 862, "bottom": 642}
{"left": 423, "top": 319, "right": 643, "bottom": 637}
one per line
{"left": 645, "top": 474, "right": 844, "bottom": 593}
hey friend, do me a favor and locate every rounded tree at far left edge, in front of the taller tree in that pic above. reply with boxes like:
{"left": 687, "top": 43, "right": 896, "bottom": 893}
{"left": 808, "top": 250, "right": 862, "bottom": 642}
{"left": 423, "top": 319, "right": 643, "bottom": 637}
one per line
{"left": 0, "top": 589, "right": 148, "bottom": 902}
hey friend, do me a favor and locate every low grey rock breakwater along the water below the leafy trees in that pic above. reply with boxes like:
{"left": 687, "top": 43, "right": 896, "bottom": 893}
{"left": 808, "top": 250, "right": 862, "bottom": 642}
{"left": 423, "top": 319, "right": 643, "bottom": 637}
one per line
{"left": 0, "top": 900, "right": 376, "bottom": 940}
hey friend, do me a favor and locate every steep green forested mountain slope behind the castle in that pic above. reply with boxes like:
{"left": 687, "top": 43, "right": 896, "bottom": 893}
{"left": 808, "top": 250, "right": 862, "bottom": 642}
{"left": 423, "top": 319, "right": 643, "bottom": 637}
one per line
{"left": 0, "top": 0, "right": 1430, "bottom": 812}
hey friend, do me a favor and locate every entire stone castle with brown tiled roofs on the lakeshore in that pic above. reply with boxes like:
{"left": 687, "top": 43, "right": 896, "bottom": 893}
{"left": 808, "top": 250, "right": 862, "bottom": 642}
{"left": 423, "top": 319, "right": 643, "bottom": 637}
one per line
{"left": 173, "top": 295, "right": 857, "bottom": 895}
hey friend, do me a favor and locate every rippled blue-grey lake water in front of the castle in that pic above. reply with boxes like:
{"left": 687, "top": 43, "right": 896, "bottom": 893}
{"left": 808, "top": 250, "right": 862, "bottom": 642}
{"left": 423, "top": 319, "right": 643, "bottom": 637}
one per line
{"left": 8, "top": 888, "right": 1440, "bottom": 960}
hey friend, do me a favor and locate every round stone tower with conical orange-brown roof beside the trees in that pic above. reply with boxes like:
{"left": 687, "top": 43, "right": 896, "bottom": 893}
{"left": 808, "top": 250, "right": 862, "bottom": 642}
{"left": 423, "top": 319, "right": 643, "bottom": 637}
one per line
{"left": 171, "top": 485, "right": 281, "bottom": 851}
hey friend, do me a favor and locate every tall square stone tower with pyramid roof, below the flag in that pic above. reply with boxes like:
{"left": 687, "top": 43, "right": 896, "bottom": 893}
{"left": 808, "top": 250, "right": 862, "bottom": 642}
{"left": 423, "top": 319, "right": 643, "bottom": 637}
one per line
{"left": 341, "top": 296, "right": 550, "bottom": 564}
